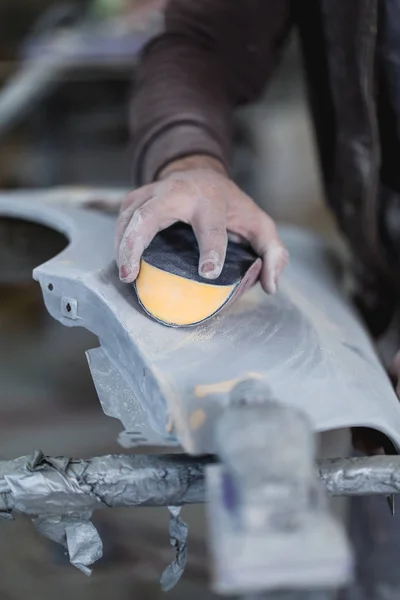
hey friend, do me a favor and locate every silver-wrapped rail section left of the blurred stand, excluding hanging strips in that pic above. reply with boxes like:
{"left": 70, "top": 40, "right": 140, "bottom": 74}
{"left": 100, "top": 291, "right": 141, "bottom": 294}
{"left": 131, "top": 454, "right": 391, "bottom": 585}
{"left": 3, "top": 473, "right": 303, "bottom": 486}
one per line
{"left": 0, "top": 452, "right": 208, "bottom": 515}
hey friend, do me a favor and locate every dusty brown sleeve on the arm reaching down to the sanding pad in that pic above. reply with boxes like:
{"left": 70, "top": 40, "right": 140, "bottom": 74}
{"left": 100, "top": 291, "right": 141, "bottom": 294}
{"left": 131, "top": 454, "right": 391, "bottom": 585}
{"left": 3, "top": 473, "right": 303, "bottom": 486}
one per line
{"left": 131, "top": 0, "right": 290, "bottom": 185}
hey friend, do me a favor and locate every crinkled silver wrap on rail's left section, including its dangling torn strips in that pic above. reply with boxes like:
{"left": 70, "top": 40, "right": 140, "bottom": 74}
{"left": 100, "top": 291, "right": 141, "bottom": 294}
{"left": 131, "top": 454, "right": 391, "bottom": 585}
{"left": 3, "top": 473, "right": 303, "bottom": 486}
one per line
{"left": 0, "top": 451, "right": 207, "bottom": 589}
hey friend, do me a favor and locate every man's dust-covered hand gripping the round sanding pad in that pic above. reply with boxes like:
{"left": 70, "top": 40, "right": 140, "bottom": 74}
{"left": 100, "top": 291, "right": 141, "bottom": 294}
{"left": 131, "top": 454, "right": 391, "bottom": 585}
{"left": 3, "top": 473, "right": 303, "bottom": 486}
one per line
{"left": 116, "top": 156, "right": 288, "bottom": 294}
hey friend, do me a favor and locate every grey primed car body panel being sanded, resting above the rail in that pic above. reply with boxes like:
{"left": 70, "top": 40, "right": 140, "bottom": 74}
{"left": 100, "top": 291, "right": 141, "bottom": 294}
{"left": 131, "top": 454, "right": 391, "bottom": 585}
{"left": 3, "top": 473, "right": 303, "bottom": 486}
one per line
{"left": 0, "top": 193, "right": 400, "bottom": 454}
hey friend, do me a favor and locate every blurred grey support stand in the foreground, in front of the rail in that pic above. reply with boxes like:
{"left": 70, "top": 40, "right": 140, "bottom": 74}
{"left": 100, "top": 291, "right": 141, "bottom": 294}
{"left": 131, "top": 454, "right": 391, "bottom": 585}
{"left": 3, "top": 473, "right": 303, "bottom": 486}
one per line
{"left": 207, "top": 394, "right": 353, "bottom": 594}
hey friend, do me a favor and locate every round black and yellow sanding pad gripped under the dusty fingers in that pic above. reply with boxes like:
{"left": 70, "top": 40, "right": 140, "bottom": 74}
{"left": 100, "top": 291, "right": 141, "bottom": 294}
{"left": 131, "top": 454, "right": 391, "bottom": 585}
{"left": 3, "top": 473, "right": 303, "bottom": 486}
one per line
{"left": 135, "top": 223, "right": 262, "bottom": 327}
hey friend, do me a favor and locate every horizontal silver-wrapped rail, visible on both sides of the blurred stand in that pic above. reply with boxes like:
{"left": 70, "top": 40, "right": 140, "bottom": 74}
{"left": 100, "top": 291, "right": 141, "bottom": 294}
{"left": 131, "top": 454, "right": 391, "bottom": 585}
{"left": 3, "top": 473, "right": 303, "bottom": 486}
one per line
{"left": 0, "top": 452, "right": 400, "bottom": 518}
